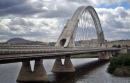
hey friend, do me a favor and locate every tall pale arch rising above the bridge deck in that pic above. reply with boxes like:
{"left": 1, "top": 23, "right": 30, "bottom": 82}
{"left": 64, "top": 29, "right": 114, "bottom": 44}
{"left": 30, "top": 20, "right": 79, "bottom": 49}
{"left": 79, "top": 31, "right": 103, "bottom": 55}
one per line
{"left": 55, "top": 6, "right": 105, "bottom": 47}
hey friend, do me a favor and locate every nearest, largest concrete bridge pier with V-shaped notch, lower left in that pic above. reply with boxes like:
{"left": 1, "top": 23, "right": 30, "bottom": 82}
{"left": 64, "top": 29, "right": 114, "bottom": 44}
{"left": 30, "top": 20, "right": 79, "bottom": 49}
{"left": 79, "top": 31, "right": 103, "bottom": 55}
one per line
{"left": 17, "top": 60, "right": 49, "bottom": 82}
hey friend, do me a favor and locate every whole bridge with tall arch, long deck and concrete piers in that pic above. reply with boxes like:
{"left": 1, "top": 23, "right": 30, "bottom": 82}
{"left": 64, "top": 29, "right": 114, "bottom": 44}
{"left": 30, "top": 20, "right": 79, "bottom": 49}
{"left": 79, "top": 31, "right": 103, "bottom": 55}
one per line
{"left": 0, "top": 6, "right": 121, "bottom": 82}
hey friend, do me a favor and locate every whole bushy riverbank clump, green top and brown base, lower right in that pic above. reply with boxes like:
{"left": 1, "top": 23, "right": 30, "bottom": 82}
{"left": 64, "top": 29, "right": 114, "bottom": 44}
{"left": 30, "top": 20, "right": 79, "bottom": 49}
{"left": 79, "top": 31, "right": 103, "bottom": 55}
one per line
{"left": 108, "top": 54, "right": 130, "bottom": 77}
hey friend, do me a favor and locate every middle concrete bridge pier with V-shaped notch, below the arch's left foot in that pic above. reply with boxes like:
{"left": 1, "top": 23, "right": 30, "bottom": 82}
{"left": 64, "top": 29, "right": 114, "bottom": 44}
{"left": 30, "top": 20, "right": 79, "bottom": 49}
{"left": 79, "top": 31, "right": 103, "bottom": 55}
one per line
{"left": 52, "top": 56, "right": 75, "bottom": 72}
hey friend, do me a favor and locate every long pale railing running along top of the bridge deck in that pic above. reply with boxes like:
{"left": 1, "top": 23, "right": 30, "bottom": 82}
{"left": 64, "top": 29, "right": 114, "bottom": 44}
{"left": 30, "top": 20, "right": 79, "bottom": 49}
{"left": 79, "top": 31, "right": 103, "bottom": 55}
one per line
{"left": 0, "top": 45, "right": 121, "bottom": 54}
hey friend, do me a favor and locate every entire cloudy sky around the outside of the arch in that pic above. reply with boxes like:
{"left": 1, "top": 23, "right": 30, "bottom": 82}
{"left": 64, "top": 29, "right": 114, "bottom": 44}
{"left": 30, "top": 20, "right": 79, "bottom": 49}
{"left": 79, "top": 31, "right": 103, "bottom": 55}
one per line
{"left": 0, "top": 0, "right": 130, "bottom": 42}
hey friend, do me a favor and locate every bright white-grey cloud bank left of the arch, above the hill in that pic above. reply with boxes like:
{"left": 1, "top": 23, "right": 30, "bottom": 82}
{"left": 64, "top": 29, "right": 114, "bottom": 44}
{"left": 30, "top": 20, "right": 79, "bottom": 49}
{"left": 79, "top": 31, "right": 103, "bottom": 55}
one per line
{"left": 0, "top": 18, "right": 63, "bottom": 42}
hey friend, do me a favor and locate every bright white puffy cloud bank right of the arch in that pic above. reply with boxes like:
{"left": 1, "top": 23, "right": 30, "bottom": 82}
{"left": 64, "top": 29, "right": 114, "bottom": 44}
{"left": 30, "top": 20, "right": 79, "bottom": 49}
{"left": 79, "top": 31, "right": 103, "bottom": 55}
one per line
{"left": 96, "top": 7, "right": 130, "bottom": 40}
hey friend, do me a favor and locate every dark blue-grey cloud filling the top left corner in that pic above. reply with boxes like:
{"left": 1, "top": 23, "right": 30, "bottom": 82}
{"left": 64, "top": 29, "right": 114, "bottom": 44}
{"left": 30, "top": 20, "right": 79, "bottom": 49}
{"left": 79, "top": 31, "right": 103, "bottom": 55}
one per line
{"left": 0, "top": 0, "right": 45, "bottom": 16}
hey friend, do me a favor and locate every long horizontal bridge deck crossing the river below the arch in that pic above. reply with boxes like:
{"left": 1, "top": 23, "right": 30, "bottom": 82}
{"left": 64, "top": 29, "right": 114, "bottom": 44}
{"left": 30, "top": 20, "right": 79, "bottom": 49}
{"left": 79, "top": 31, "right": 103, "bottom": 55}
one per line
{"left": 0, "top": 48, "right": 120, "bottom": 64}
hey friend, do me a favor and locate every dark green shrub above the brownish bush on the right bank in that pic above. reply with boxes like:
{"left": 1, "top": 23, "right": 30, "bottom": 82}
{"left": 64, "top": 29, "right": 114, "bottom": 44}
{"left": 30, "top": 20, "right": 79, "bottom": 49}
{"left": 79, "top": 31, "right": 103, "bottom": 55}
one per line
{"left": 108, "top": 54, "right": 130, "bottom": 73}
